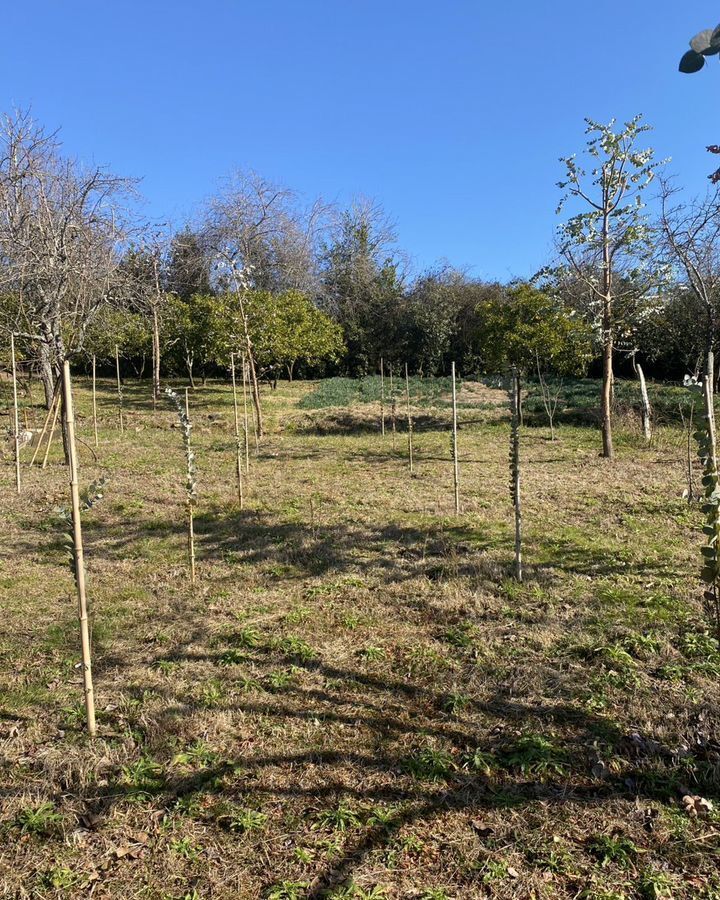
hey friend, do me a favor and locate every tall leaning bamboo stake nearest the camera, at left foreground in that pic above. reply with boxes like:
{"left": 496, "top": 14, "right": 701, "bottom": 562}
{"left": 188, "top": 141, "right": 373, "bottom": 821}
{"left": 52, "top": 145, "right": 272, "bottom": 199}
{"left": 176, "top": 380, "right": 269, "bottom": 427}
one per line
{"left": 58, "top": 361, "right": 96, "bottom": 737}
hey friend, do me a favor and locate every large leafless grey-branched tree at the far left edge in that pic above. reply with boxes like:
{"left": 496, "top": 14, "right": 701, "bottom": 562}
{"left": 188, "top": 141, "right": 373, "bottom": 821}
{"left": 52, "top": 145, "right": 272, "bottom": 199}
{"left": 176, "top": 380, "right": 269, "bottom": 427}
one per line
{"left": 0, "top": 112, "right": 133, "bottom": 407}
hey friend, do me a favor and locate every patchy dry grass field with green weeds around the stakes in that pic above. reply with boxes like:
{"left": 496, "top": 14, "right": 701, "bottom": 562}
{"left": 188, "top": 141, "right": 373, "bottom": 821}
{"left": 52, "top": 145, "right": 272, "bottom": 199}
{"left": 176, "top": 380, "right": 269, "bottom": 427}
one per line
{"left": 0, "top": 383, "right": 720, "bottom": 900}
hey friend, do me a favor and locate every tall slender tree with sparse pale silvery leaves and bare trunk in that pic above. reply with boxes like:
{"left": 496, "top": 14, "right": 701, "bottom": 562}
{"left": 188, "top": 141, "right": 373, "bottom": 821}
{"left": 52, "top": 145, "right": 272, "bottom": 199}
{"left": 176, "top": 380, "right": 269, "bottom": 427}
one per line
{"left": 558, "top": 116, "right": 661, "bottom": 458}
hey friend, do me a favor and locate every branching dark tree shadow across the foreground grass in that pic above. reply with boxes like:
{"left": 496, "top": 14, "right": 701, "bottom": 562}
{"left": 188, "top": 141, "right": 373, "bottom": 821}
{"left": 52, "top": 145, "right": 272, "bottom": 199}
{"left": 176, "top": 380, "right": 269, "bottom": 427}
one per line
{"left": 76, "top": 635, "right": 718, "bottom": 898}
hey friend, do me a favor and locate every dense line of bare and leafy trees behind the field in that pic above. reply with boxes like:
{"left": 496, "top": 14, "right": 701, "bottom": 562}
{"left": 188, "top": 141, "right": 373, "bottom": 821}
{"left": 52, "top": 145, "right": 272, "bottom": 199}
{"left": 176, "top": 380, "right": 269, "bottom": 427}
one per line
{"left": 0, "top": 108, "right": 720, "bottom": 412}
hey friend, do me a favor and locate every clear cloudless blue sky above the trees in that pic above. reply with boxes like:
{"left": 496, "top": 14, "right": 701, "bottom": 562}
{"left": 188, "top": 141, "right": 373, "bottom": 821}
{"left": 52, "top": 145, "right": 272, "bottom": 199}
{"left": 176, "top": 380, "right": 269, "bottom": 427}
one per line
{"left": 0, "top": 0, "right": 720, "bottom": 279}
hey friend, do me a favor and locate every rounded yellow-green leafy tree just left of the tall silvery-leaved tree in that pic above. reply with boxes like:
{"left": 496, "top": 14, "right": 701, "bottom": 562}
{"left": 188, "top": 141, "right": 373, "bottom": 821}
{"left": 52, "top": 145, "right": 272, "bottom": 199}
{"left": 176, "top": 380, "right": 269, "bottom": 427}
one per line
{"left": 477, "top": 283, "right": 592, "bottom": 375}
